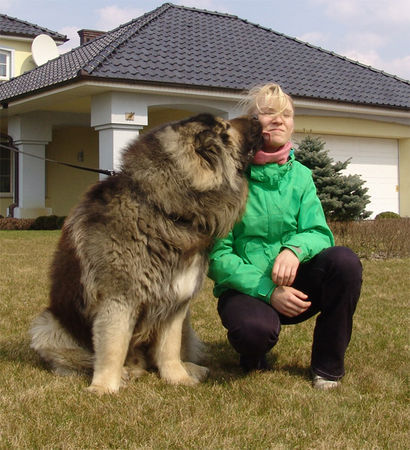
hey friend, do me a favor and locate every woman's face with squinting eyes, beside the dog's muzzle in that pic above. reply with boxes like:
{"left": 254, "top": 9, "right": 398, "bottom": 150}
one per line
{"left": 258, "top": 102, "right": 293, "bottom": 152}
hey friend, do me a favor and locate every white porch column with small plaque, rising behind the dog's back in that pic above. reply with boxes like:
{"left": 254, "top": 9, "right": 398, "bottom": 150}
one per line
{"left": 91, "top": 92, "right": 148, "bottom": 178}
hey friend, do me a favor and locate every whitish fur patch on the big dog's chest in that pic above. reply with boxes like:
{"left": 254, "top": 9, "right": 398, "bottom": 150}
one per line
{"left": 171, "top": 255, "right": 204, "bottom": 301}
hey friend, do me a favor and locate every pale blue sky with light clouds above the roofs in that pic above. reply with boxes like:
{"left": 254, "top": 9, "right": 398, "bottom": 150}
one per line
{"left": 0, "top": 0, "right": 410, "bottom": 80}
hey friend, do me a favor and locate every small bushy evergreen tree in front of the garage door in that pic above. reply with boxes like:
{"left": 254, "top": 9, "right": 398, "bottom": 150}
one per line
{"left": 295, "top": 136, "right": 371, "bottom": 221}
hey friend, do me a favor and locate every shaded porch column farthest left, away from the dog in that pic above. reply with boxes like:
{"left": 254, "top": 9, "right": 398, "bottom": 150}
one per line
{"left": 8, "top": 115, "right": 52, "bottom": 218}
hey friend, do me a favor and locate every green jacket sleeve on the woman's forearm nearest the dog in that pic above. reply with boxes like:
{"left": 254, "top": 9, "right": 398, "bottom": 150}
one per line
{"left": 208, "top": 231, "right": 276, "bottom": 303}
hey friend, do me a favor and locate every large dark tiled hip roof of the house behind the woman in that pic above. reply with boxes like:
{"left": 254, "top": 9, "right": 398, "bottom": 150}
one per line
{"left": 0, "top": 3, "right": 410, "bottom": 109}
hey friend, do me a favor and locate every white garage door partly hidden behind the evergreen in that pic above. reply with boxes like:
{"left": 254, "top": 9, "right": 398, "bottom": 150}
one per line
{"left": 294, "top": 133, "right": 399, "bottom": 218}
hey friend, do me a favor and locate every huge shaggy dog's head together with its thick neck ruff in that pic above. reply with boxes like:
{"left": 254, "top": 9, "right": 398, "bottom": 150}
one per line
{"left": 123, "top": 114, "right": 263, "bottom": 236}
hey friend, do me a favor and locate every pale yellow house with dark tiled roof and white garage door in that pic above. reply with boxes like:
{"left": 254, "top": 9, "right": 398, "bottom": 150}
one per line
{"left": 0, "top": 3, "right": 410, "bottom": 217}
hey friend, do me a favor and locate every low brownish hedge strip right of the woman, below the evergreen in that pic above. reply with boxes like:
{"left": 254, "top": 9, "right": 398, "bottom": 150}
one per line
{"left": 329, "top": 218, "right": 410, "bottom": 259}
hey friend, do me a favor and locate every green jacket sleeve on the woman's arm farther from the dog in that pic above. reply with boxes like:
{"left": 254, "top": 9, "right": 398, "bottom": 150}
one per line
{"left": 282, "top": 175, "right": 335, "bottom": 263}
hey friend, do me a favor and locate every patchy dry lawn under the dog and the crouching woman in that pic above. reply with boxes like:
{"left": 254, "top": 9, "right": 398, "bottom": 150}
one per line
{"left": 0, "top": 231, "right": 410, "bottom": 449}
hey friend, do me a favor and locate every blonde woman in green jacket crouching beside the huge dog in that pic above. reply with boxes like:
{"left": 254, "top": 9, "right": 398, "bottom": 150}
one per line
{"left": 209, "top": 84, "right": 362, "bottom": 390}
